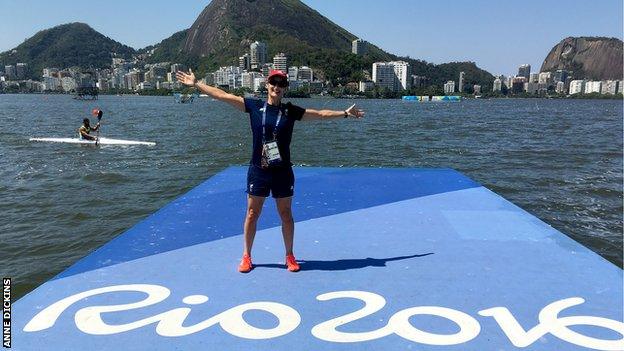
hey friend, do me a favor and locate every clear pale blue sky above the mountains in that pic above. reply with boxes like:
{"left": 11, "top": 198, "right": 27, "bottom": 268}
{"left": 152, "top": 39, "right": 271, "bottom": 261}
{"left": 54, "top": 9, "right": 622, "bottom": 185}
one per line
{"left": 0, "top": 0, "right": 624, "bottom": 74}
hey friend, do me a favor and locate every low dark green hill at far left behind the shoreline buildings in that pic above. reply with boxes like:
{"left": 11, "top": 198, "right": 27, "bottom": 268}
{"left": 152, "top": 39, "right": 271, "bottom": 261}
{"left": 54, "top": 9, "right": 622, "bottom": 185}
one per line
{"left": 0, "top": 23, "right": 135, "bottom": 79}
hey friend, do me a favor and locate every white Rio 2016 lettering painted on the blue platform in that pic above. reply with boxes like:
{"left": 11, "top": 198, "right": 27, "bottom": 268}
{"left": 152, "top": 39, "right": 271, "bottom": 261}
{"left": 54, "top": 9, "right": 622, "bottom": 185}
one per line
{"left": 24, "top": 284, "right": 624, "bottom": 350}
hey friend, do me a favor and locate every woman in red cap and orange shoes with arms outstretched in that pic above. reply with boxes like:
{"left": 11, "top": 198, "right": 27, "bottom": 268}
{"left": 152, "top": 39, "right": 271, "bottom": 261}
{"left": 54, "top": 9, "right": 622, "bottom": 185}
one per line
{"left": 176, "top": 70, "right": 364, "bottom": 273}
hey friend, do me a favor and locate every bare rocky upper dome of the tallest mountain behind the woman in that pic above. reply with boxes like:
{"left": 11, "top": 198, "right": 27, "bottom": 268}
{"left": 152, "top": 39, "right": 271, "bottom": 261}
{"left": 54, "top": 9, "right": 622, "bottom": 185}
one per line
{"left": 184, "top": 0, "right": 357, "bottom": 56}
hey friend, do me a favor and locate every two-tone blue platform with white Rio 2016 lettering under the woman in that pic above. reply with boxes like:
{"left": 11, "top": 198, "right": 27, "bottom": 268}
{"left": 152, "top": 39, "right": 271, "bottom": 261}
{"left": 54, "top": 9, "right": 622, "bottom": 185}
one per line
{"left": 13, "top": 167, "right": 624, "bottom": 350}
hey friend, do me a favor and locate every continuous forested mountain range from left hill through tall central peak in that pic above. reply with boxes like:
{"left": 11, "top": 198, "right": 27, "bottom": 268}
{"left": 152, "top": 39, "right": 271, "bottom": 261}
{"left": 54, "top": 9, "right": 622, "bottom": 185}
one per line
{"left": 0, "top": 0, "right": 494, "bottom": 89}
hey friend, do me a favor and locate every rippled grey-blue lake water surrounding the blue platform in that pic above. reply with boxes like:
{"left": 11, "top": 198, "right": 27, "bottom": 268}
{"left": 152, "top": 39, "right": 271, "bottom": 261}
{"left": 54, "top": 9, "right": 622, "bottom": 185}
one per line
{"left": 0, "top": 95, "right": 623, "bottom": 297}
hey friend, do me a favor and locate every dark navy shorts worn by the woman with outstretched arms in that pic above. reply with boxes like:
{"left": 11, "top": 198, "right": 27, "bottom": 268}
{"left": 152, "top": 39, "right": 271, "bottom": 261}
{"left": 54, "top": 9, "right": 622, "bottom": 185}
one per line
{"left": 247, "top": 165, "right": 295, "bottom": 199}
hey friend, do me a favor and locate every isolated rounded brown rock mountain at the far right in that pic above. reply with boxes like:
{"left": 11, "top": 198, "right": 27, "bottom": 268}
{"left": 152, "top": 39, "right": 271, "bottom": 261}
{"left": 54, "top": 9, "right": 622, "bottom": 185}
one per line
{"left": 540, "top": 37, "right": 623, "bottom": 80}
